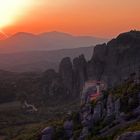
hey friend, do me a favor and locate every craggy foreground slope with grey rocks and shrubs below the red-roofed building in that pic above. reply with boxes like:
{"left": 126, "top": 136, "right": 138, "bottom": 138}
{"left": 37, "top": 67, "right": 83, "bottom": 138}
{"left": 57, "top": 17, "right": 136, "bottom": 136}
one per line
{"left": 39, "top": 77, "right": 140, "bottom": 140}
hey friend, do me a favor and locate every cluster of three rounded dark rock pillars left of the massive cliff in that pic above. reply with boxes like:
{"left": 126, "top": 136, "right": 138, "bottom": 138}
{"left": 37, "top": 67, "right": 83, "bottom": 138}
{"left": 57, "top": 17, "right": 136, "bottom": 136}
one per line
{"left": 41, "top": 55, "right": 87, "bottom": 103}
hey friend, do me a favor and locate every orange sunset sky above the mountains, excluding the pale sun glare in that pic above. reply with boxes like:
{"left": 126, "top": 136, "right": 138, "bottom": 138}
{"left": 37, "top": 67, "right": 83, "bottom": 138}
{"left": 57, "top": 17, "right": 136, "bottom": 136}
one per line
{"left": 0, "top": 0, "right": 140, "bottom": 37}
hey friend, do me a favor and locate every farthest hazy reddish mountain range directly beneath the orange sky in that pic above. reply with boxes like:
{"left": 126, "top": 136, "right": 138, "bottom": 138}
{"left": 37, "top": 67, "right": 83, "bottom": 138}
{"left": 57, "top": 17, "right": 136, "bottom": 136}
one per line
{"left": 0, "top": 31, "right": 108, "bottom": 53}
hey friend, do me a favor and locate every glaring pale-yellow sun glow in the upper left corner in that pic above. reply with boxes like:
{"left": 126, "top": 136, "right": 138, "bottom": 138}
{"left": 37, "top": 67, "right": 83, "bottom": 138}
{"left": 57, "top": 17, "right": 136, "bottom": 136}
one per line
{"left": 0, "top": 0, "right": 33, "bottom": 28}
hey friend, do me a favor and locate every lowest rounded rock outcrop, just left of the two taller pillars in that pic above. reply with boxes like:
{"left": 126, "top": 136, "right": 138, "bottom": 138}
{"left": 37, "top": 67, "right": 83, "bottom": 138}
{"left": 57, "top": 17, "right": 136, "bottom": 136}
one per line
{"left": 42, "top": 69, "right": 67, "bottom": 102}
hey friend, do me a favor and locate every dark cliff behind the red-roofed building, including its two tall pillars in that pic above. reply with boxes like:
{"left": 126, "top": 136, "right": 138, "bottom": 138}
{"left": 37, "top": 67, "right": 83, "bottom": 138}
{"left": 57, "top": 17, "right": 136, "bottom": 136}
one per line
{"left": 46, "top": 31, "right": 140, "bottom": 97}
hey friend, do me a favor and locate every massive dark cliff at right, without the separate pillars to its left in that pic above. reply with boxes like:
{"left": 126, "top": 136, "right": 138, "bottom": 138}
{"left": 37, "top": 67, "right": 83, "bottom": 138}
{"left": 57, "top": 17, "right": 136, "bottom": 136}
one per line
{"left": 88, "top": 31, "right": 140, "bottom": 86}
